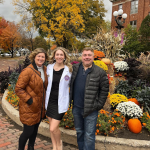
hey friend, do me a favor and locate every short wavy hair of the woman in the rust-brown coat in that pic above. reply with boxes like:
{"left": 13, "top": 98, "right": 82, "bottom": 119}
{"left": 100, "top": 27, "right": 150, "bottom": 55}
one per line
{"left": 29, "top": 48, "right": 49, "bottom": 62}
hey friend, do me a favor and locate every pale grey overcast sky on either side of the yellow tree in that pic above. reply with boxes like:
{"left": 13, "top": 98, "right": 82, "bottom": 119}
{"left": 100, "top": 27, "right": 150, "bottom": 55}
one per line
{"left": 0, "top": 0, "right": 112, "bottom": 36}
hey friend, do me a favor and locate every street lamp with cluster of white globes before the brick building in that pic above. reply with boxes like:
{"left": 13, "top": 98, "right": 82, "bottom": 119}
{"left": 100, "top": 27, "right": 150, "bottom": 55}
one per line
{"left": 113, "top": 9, "right": 127, "bottom": 31}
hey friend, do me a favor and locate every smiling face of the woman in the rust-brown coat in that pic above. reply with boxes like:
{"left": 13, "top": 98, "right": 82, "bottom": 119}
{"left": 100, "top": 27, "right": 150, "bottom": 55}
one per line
{"left": 34, "top": 53, "right": 45, "bottom": 67}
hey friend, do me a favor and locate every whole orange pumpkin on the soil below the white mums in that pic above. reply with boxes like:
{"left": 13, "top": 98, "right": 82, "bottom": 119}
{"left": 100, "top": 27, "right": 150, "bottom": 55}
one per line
{"left": 128, "top": 118, "right": 142, "bottom": 133}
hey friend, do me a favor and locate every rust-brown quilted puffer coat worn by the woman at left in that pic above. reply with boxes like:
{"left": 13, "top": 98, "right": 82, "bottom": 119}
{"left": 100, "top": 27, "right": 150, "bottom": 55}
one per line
{"left": 15, "top": 63, "right": 48, "bottom": 126}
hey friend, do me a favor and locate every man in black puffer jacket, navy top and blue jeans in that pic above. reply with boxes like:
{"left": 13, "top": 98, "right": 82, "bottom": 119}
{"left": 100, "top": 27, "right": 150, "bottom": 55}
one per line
{"left": 70, "top": 48, "right": 109, "bottom": 150}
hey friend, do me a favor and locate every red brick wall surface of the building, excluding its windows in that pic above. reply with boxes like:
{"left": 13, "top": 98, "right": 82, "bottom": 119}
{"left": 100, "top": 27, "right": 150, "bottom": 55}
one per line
{"left": 111, "top": 0, "right": 150, "bottom": 29}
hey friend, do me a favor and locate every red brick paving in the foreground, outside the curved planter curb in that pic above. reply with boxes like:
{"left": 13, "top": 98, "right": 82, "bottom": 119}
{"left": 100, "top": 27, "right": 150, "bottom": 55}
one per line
{"left": 0, "top": 96, "right": 78, "bottom": 150}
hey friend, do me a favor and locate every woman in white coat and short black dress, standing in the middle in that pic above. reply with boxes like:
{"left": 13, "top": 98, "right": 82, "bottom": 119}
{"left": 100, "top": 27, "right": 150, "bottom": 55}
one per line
{"left": 45, "top": 47, "right": 72, "bottom": 150}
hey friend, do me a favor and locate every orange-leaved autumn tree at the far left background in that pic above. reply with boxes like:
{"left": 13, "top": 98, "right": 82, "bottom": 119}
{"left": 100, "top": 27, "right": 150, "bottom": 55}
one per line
{"left": 0, "top": 22, "right": 20, "bottom": 57}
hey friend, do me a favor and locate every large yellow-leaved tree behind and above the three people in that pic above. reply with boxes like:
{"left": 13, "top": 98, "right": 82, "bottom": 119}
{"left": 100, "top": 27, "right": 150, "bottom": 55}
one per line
{"left": 14, "top": 0, "right": 106, "bottom": 47}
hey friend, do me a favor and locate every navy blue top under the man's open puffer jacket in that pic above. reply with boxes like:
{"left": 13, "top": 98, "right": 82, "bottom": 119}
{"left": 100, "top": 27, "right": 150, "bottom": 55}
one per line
{"left": 73, "top": 63, "right": 91, "bottom": 108}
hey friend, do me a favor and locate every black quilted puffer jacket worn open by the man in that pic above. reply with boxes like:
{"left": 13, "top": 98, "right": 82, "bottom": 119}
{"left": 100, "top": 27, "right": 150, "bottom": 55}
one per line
{"left": 70, "top": 63, "right": 109, "bottom": 117}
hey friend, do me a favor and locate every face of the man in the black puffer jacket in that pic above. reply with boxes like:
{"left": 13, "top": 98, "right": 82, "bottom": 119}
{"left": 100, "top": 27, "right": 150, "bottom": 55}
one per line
{"left": 82, "top": 50, "right": 94, "bottom": 67}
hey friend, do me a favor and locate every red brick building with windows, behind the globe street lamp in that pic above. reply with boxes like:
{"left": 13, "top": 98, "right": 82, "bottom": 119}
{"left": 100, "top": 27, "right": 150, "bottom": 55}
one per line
{"left": 110, "top": 0, "right": 150, "bottom": 29}
